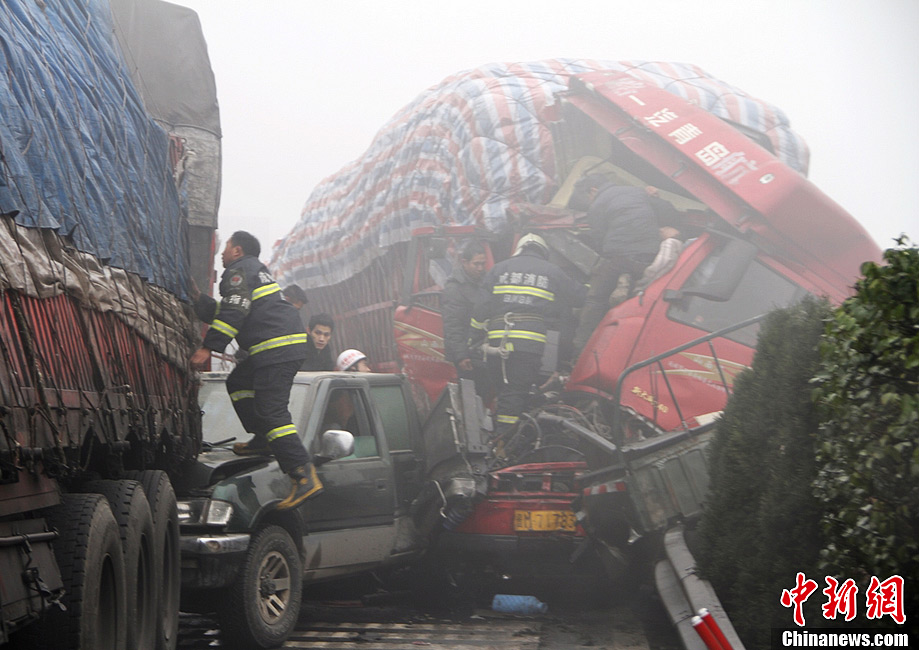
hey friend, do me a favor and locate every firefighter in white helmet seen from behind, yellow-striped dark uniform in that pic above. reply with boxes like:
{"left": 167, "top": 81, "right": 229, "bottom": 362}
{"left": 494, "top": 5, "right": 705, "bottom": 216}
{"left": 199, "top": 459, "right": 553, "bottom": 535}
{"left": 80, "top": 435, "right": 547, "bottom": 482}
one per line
{"left": 471, "top": 234, "right": 587, "bottom": 436}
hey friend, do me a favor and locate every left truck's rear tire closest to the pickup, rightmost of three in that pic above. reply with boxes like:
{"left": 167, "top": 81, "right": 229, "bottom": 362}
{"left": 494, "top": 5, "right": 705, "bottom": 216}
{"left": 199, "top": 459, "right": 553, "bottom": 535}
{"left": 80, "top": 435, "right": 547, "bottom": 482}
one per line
{"left": 125, "top": 470, "right": 182, "bottom": 650}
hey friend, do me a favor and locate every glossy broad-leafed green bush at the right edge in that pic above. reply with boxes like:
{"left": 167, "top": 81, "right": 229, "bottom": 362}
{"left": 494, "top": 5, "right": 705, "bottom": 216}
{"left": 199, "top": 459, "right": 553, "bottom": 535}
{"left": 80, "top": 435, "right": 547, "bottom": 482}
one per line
{"left": 814, "top": 237, "right": 919, "bottom": 625}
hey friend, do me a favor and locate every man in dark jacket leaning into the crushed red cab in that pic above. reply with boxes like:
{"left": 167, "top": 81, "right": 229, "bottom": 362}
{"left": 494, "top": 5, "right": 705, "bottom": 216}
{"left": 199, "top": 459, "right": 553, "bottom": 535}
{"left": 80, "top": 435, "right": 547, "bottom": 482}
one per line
{"left": 574, "top": 175, "right": 666, "bottom": 352}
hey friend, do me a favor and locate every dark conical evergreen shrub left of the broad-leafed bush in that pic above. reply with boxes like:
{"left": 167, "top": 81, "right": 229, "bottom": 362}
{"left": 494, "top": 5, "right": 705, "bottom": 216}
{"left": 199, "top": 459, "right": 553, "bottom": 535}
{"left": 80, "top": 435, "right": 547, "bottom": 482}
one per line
{"left": 698, "top": 299, "right": 832, "bottom": 648}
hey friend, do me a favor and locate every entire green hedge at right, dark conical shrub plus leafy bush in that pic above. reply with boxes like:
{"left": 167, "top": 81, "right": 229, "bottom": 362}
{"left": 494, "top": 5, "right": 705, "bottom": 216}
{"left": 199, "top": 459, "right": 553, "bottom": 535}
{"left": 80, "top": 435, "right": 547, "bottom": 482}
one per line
{"left": 698, "top": 238, "right": 919, "bottom": 648}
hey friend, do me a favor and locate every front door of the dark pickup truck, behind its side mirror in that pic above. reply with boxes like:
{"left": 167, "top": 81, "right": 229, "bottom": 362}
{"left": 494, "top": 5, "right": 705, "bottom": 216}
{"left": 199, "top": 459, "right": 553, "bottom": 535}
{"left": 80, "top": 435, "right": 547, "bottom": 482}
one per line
{"left": 304, "top": 380, "right": 396, "bottom": 577}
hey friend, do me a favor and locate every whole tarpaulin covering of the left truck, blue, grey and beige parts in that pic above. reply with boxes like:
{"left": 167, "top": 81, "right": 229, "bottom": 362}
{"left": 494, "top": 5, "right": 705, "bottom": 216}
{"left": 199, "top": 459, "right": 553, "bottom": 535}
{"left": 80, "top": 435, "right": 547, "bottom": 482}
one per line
{"left": 0, "top": 0, "right": 220, "bottom": 368}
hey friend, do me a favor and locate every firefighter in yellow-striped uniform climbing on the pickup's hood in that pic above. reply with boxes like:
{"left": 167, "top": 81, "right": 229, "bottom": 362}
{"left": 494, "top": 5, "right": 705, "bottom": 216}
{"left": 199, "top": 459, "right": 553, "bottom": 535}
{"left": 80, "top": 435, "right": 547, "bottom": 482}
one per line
{"left": 191, "top": 230, "right": 322, "bottom": 510}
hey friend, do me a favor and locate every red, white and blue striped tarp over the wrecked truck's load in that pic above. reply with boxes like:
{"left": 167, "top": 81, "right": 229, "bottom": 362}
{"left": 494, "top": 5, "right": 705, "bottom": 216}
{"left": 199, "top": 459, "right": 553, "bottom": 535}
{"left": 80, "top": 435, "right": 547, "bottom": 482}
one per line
{"left": 272, "top": 59, "right": 808, "bottom": 292}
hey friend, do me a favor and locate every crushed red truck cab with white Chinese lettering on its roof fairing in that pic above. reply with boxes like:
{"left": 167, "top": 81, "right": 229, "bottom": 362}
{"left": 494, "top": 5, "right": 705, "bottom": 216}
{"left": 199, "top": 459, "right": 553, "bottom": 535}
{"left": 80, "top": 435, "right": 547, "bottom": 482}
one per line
{"left": 395, "top": 71, "right": 880, "bottom": 431}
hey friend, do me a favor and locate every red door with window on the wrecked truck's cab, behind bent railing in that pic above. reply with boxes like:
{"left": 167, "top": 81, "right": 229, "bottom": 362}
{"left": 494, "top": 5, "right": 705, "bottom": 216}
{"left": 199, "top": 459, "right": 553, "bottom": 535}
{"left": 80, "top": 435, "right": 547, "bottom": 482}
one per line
{"left": 584, "top": 235, "right": 807, "bottom": 431}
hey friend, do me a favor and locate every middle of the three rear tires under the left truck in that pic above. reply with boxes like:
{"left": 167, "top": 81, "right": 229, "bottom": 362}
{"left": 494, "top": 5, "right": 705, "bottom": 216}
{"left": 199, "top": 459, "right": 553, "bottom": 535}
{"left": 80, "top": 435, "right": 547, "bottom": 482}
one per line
{"left": 82, "top": 481, "right": 157, "bottom": 650}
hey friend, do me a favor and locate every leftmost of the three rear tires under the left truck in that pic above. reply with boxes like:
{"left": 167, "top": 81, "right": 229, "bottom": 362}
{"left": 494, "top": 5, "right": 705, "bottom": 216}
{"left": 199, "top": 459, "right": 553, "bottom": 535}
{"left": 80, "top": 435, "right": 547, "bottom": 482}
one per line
{"left": 32, "top": 494, "right": 127, "bottom": 650}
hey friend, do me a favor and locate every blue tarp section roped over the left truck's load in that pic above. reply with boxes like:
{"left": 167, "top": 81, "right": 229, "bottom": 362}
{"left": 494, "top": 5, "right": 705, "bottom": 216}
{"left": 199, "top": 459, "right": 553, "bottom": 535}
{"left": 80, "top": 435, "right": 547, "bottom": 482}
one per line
{"left": 0, "top": 0, "right": 196, "bottom": 296}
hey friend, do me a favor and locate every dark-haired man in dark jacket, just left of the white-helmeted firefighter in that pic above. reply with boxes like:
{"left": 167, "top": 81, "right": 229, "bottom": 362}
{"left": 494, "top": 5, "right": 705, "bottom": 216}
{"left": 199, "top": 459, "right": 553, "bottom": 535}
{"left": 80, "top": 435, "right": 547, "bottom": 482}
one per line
{"left": 441, "top": 240, "right": 487, "bottom": 379}
